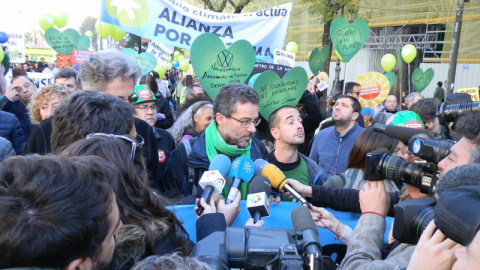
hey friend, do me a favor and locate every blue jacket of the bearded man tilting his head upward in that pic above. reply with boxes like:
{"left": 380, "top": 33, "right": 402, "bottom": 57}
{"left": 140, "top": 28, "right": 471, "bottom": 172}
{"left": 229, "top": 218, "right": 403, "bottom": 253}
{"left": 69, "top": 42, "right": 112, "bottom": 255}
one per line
{"left": 309, "top": 124, "right": 363, "bottom": 178}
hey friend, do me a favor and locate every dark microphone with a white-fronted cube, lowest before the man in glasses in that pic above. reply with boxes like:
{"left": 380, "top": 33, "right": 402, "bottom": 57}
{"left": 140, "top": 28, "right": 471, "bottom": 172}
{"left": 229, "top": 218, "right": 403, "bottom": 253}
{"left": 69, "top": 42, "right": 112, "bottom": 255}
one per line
{"left": 247, "top": 175, "right": 272, "bottom": 223}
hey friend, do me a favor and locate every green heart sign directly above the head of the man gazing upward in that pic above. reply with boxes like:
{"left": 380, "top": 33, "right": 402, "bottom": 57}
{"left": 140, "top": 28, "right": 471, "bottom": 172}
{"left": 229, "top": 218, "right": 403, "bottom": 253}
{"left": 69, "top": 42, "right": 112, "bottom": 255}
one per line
{"left": 253, "top": 67, "right": 308, "bottom": 121}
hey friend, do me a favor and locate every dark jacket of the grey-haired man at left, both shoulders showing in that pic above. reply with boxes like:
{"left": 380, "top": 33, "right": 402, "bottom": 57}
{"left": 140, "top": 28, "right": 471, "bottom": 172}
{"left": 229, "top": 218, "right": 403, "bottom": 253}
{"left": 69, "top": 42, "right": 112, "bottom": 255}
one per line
{"left": 23, "top": 117, "right": 158, "bottom": 180}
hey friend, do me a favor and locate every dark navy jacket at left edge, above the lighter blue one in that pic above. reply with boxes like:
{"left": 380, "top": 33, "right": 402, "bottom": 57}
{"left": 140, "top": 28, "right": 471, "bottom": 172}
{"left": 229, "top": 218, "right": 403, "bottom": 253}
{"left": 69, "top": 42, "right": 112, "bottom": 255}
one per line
{"left": 0, "top": 111, "right": 27, "bottom": 155}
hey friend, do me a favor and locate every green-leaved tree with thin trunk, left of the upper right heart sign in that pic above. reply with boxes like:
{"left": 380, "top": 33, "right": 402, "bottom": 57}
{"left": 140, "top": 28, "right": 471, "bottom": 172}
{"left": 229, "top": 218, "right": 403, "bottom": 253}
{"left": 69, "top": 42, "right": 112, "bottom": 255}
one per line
{"left": 302, "top": 0, "right": 358, "bottom": 77}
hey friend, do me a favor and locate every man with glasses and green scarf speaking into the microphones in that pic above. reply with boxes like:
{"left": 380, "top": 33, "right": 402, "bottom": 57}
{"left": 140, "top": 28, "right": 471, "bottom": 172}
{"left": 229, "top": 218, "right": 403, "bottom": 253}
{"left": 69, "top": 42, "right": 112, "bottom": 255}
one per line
{"left": 162, "top": 83, "right": 268, "bottom": 204}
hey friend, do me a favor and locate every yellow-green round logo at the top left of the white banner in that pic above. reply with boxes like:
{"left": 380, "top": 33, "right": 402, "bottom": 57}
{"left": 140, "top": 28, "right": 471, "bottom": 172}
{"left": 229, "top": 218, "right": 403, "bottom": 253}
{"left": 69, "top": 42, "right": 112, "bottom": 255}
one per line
{"left": 104, "top": 0, "right": 149, "bottom": 27}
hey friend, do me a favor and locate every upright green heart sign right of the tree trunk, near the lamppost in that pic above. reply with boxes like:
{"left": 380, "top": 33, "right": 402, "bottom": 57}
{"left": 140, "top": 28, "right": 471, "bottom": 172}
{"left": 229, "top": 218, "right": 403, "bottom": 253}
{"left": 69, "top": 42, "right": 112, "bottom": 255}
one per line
{"left": 330, "top": 17, "right": 370, "bottom": 62}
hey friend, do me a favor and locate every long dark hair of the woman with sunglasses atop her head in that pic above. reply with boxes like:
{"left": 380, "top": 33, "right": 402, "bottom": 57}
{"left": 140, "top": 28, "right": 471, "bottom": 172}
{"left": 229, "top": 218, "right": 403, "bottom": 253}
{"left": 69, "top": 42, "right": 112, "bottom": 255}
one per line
{"left": 61, "top": 137, "right": 190, "bottom": 264}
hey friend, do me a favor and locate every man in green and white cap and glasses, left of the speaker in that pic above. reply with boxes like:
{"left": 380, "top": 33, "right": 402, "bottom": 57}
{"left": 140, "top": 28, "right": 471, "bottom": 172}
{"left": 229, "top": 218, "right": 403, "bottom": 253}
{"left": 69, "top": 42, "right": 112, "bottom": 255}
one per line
{"left": 130, "top": 85, "right": 175, "bottom": 188}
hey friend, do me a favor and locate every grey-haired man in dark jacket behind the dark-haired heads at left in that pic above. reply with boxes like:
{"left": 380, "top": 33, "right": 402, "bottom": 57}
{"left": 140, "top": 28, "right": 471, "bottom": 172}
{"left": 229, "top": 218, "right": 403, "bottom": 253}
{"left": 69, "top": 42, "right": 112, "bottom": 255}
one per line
{"left": 24, "top": 50, "right": 160, "bottom": 179}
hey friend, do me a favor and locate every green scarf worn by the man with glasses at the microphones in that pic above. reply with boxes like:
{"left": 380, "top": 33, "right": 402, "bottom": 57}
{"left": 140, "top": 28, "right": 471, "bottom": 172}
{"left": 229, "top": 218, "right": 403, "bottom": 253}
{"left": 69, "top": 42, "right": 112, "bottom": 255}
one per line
{"left": 205, "top": 121, "right": 252, "bottom": 200}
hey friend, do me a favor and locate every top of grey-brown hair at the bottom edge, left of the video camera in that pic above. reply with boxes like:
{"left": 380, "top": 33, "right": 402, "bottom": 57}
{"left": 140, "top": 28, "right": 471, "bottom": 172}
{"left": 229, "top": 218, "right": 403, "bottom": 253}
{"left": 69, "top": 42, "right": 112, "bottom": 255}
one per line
{"left": 132, "top": 253, "right": 210, "bottom": 270}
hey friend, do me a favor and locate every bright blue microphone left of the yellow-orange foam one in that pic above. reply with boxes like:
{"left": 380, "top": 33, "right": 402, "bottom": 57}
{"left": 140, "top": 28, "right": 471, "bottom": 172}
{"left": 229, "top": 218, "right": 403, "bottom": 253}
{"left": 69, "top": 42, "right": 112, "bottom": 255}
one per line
{"left": 225, "top": 156, "right": 254, "bottom": 204}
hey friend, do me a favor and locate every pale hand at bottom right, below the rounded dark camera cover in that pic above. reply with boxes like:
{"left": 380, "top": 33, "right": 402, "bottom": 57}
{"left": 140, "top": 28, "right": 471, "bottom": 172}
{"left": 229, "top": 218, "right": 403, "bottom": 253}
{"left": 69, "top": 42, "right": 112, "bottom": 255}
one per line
{"left": 407, "top": 220, "right": 460, "bottom": 270}
